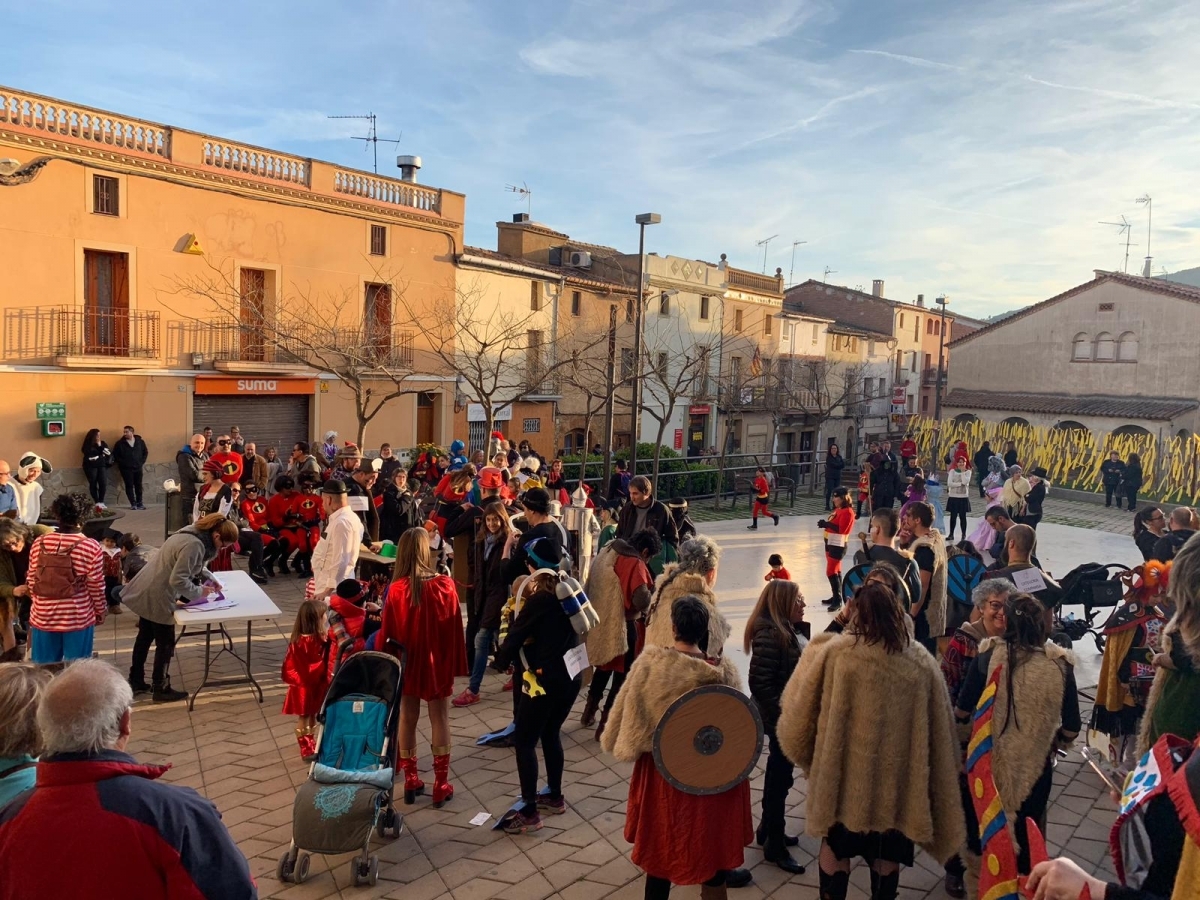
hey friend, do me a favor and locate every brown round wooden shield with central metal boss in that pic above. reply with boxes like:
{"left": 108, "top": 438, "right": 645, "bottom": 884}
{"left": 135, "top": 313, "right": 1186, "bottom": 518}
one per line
{"left": 654, "top": 684, "right": 762, "bottom": 794}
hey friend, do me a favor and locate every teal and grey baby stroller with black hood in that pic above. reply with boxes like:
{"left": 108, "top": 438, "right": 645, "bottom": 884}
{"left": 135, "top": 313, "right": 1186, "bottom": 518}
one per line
{"left": 275, "top": 650, "right": 404, "bottom": 887}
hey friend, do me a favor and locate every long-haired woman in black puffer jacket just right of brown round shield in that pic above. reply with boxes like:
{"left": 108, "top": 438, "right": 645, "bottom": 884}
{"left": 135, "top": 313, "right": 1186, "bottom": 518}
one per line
{"left": 742, "top": 578, "right": 808, "bottom": 875}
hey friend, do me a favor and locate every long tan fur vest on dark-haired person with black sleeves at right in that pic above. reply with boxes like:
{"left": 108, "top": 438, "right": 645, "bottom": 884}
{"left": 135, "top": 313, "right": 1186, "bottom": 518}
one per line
{"left": 979, "top": 637, "right": 1075, "bottom": 822}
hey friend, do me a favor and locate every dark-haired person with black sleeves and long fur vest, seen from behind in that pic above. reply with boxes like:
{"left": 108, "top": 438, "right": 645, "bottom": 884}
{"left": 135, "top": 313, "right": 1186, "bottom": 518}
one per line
{"left": 955, "top": 593, "right": 1082, "bottom": 888}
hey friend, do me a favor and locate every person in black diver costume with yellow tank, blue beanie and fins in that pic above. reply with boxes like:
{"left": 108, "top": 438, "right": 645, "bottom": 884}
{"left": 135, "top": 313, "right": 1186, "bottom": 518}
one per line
{"left": 496, "top": 538, "right": 581, "bottom": 834}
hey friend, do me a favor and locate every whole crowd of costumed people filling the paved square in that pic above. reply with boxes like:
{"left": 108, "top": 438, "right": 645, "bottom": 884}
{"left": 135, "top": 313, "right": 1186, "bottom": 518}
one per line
{"left": 0, "top": 428, "right": 1200, "bottom": 900}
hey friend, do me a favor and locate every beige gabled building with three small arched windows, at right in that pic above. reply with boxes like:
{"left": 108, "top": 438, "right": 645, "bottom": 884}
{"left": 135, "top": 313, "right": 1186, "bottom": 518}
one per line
{"left": 943, "top": 271, "right": 1200, "bottom": 438}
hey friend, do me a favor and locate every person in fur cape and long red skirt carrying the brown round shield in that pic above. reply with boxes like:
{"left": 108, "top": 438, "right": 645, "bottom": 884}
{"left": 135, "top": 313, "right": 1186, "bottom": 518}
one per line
{"left": 601, "top": 596, "right": 754, "bottom": 900}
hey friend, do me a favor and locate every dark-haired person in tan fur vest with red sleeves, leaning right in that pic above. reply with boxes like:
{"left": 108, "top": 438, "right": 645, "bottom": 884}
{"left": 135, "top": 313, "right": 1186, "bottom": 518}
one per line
{"left": 580, "top": 528, "right": 662, "bottom": 740}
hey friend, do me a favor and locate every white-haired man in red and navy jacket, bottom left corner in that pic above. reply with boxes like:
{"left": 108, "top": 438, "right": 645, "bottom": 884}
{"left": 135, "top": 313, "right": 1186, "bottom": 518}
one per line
{"left": 0, "top": 659, "right": 258, "bottom": 900}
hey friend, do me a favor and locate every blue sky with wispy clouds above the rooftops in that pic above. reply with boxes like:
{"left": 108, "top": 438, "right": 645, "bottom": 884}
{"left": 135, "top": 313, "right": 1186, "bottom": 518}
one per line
{"left": 0, "top": 0, "right": 1200, "bottom": 317}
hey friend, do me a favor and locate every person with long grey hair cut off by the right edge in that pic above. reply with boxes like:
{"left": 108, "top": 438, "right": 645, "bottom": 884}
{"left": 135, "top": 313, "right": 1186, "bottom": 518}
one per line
{"left": 1138, "top": 536, "right": 1200, "bottom": 754}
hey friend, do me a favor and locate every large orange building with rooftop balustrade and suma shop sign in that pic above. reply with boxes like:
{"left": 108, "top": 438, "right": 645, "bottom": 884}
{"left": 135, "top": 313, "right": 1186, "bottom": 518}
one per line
{"left": 0, "top": 88, "right": 464, "bottom": 501}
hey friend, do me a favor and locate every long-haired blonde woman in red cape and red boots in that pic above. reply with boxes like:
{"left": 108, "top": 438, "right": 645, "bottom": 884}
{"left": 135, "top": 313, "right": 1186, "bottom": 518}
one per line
{"left": 377, "top": 528, "right": 467, "bottom": 808}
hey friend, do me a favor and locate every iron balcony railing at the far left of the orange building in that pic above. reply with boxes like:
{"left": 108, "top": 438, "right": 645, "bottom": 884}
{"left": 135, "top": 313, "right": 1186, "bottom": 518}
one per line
{"left": 4, "top": 306, "right": 161, "bottom": 360}
